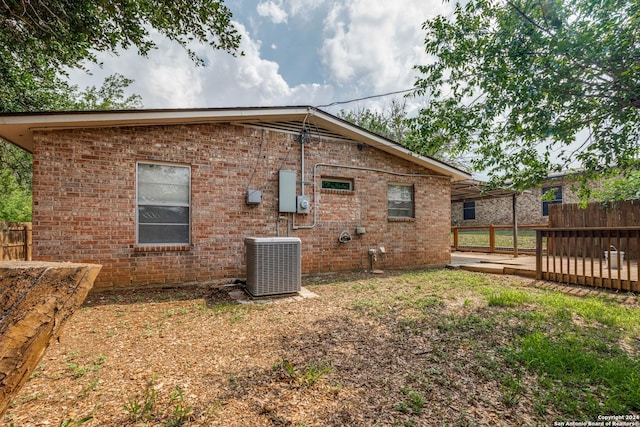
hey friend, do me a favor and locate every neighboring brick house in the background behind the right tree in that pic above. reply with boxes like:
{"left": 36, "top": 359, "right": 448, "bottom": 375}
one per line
{"left": 451, "top": 173, "right": 578, "bottom": 226}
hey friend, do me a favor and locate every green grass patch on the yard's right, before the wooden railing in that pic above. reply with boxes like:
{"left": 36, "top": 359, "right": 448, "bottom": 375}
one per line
{"left": 384, "top": 270, "right": 640, "bottom": 420}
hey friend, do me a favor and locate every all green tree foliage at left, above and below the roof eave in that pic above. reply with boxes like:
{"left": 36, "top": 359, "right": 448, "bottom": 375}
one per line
{"left": 0, "top": 0, "right": 240, "bottom": 221}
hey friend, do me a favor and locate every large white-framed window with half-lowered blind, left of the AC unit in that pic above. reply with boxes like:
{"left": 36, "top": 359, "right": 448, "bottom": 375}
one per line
{"left": 136, "top": 163, "right": 191, "bottom": 245}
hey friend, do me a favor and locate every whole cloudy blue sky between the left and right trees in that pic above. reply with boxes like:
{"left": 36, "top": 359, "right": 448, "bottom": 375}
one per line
{"left": 71, "top": 0, "right": 452, "bottom": 113}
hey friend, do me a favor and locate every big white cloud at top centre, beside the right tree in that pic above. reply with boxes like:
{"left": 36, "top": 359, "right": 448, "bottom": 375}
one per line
{"left": 321, "top": 0, "right": 450, "bottom": 92}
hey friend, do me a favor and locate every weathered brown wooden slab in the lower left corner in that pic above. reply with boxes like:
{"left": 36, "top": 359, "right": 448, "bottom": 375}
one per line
{"left": 0, "top": 261, "right": 102, "bottom": 418}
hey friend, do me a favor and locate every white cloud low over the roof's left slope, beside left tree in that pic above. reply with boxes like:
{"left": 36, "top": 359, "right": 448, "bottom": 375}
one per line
{"left": 70, "top": 23, "right": 340, "bottom": 108}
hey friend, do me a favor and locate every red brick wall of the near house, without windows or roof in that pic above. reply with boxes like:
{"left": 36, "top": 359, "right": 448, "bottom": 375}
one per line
{"left": 33, "top": 124, "right": 450, "bottom": 288}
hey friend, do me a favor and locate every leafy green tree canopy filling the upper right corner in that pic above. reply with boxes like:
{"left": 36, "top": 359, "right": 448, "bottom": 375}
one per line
{"left": 414, "top": 0, "right": 640, "bottom": 189}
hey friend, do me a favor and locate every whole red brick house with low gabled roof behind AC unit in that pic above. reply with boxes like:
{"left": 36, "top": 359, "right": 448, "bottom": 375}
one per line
{"left": 0, "top": 107, "right": 470, "bottom": 289}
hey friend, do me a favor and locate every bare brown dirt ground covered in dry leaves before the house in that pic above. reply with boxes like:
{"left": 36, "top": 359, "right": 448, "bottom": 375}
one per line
{"left": 0, "top": 273, "right": 636, "bottom": 427}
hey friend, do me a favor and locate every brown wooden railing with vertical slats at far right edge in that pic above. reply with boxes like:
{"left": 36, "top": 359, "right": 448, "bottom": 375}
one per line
{"left": 536, "top": 227, "right": 640, "bottom": 292}
